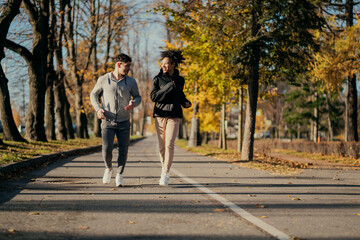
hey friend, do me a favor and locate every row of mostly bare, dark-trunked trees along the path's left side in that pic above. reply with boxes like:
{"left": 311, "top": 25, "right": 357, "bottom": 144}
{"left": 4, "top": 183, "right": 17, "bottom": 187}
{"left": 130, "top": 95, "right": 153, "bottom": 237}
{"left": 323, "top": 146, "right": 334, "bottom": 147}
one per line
{"left": 0, "top": 0, "right": 155, "bottom": 144}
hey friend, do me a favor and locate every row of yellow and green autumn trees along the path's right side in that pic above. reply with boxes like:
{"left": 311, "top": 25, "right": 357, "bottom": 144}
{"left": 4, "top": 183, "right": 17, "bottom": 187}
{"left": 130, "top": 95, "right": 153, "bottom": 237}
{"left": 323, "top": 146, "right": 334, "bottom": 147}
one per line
{"left": 155, "top": 0, "right": 360, "bottom": 160}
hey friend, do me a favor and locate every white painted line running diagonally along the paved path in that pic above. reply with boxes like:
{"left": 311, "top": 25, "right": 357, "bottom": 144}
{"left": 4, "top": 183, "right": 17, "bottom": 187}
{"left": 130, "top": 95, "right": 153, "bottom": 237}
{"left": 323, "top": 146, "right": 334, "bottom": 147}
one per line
{"left": 170, "top": 168, "right": 291, "bottom": 240}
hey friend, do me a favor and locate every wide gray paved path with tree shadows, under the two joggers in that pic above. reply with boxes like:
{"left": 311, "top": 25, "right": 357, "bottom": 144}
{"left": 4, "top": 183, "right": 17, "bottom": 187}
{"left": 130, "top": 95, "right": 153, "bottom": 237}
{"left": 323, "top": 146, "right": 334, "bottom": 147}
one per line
{"left": 0, "top": 137, "right": 360, "bottom": 240}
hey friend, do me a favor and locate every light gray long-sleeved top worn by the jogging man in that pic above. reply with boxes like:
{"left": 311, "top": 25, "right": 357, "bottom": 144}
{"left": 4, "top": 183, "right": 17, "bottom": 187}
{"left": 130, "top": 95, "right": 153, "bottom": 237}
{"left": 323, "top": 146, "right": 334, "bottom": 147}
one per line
{"left": 90, "top": 72, "right": 141, "bottom": 122}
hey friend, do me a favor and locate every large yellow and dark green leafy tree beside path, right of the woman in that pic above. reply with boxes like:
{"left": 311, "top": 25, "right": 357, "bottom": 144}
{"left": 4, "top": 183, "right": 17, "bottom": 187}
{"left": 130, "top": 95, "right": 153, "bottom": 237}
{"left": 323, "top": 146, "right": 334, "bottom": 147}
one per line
{"left": 158, "top": 0, "right": 322, "bottom": 160}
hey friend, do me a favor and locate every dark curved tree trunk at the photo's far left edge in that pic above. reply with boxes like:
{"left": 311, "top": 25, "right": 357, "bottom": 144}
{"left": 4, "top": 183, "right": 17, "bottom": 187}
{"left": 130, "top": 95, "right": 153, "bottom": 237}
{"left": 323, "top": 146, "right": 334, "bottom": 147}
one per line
{"left": 0, "top": 0, "right": 26, "bottom": 144}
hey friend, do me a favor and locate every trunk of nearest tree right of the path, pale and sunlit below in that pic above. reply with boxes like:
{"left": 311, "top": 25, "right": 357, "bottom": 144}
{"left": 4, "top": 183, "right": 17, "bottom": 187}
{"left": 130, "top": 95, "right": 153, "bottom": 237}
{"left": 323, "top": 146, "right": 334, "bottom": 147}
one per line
{"left": 241, "top": 0, "right": 260, "bottom": 161}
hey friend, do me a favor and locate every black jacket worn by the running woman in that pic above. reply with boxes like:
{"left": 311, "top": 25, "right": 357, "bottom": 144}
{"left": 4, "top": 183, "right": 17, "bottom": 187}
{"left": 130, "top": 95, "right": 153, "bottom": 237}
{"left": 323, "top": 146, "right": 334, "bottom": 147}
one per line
{"left": 150, "top": 69, "right": 191, "bottom": 118}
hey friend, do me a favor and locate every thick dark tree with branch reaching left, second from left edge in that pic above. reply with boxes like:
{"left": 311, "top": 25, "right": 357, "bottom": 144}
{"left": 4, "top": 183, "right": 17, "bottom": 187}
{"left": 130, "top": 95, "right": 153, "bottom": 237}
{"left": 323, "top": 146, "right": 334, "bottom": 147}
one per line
{"left": 5, "top": 0, "right": 49, "bottom": 141}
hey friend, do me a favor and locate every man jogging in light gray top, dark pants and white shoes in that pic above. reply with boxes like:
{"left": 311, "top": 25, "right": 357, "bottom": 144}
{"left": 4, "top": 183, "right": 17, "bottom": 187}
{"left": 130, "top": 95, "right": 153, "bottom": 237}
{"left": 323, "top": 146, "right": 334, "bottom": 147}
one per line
{"left": 90, "top": 53, "right": 141, "bottom": 187}
